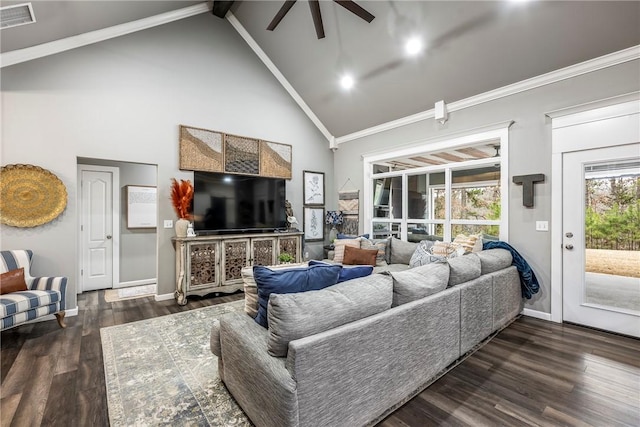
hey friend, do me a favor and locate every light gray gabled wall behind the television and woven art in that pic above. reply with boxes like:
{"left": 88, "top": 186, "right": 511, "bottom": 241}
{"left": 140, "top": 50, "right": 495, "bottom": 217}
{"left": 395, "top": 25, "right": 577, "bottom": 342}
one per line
{"left": 0, "top": 13, "right": 333, "bottom": 308}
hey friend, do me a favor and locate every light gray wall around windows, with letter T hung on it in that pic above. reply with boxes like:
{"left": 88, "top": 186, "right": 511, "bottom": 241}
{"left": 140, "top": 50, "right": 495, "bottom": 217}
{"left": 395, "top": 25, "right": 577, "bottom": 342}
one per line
{"left": 334, "top": 61, "right": 640, "bottom": 313}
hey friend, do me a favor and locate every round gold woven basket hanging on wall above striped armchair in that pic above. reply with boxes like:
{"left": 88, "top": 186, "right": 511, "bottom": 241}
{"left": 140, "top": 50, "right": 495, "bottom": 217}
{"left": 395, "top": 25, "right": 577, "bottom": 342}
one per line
{"left": 0, "top": 164, "right": 67, "bottom": 228}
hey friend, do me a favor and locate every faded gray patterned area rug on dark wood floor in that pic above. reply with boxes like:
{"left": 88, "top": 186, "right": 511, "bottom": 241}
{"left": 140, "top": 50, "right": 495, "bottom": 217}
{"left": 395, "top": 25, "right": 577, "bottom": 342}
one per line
{"left": 100, "top": 300, "right": 251, "bottom": 426}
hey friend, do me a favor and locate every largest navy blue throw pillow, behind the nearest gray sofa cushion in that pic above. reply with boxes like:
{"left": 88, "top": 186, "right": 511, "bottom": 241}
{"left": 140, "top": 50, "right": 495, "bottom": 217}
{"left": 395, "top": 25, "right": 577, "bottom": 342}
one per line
{"left": 253, "top": 264, "right": 342, "bottom": 328}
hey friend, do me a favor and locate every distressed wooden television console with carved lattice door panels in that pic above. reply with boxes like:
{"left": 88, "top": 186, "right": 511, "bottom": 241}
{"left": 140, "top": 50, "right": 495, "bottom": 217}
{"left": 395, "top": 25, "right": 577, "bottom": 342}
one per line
{"left": 171, "top": 231, "right": 304, "bottom": 305}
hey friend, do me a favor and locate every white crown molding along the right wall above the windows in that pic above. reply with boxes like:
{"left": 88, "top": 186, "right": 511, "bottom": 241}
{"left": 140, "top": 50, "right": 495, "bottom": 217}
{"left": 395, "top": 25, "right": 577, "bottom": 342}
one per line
{"left": 335, "top": 45, "right": 640, "bottom": 146}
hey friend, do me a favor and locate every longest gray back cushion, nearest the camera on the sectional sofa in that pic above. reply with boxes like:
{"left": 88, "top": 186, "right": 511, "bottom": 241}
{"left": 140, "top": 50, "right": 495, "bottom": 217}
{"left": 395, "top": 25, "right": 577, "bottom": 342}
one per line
{"left": 268, "top": 274, "right": 393, "bottom": 357}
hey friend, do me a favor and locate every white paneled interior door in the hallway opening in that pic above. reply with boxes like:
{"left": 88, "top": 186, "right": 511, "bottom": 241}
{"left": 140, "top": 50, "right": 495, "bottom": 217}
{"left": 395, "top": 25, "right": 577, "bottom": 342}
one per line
{"left": 80, "top": 166, "right": 118, "bottom": 291}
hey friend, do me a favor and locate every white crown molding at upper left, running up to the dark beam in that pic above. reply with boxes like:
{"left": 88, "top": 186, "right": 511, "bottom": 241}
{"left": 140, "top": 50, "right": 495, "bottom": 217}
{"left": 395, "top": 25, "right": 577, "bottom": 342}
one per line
{"left": 0, "top": 2, "right": 211, "bottom": 68}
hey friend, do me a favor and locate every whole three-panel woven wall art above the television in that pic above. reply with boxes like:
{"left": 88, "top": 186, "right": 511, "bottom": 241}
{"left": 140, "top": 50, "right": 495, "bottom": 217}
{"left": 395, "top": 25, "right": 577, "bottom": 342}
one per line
{"left": 179, "top": 125, "right": 293, "bottom": 179}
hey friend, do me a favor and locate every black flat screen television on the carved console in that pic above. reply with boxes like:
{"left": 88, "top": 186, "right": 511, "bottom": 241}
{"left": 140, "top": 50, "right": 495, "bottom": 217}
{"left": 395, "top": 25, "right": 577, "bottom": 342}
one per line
{"left": 193, "top": 172, "right": 286, "bottom": 234}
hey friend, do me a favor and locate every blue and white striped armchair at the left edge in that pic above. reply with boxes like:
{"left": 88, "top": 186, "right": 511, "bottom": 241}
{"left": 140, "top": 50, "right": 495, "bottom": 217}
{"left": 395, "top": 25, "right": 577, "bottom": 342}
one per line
{"left": 0, "top": 250, "right": 67, "bottom": 331}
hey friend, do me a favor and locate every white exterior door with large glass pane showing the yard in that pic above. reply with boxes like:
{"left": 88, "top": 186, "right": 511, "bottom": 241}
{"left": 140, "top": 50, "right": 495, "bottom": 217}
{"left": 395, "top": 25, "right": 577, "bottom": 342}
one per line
{"left": 562, "top": 143, "right": 640, "bottom": 337}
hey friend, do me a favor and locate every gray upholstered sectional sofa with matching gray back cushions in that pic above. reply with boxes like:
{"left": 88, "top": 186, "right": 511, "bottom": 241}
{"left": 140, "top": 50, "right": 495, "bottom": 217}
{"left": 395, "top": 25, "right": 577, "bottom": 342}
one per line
{"left": 211, "top": 249, "right": 523, "bottom": 427}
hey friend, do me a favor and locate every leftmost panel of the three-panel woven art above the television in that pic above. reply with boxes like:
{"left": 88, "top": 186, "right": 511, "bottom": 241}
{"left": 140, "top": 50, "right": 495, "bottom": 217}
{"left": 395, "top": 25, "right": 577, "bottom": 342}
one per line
{"left": 180, "top": 125, "right": 224, "bottom": 172}
